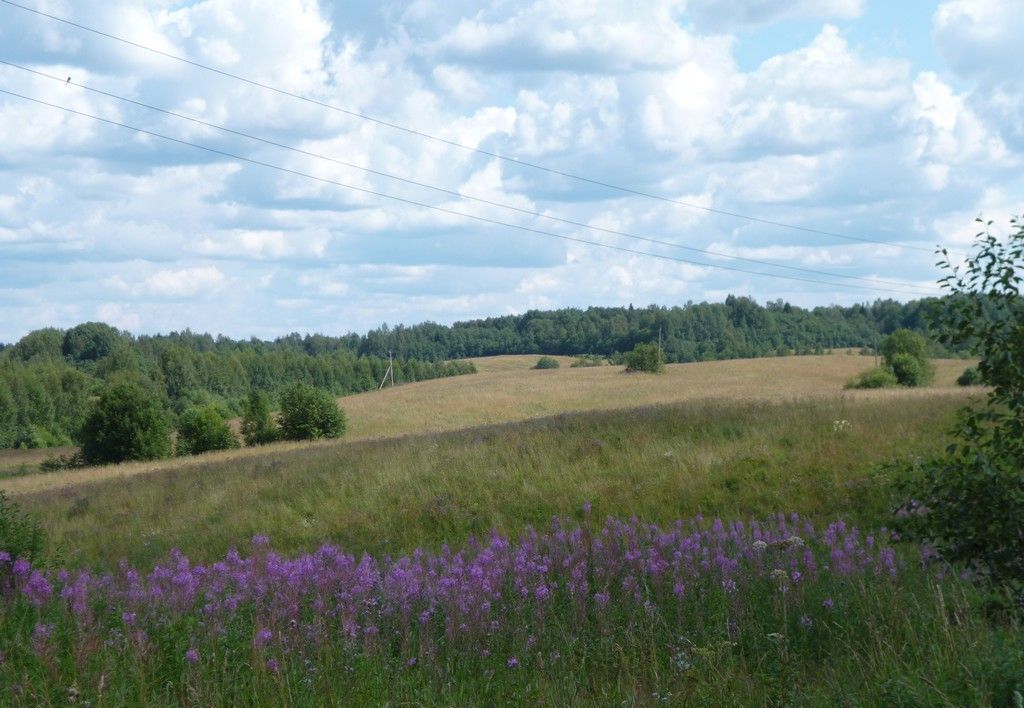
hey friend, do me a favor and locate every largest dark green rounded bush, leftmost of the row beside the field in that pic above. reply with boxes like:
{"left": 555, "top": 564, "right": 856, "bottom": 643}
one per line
{"left": 80, "top": 381, "right": 171, "bottom": 464}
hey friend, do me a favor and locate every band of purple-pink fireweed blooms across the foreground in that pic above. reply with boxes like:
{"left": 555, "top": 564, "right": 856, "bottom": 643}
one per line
{"left": 0, "top": 514, "right": 917, "bottom": 668}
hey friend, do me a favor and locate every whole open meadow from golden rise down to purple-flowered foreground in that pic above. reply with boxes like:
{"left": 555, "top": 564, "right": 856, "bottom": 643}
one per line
{"left": 0, "top": 355, "right": 1024, "bottom": 706}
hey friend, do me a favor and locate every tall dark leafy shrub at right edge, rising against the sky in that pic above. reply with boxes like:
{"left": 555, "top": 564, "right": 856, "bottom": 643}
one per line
{"left": 898, "top": 219, "right": 1024, "bottom": 594}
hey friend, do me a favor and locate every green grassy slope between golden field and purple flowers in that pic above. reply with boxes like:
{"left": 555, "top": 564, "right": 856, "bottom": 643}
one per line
{"left": 16, "top": 391, "right": 965, "bottom": 566}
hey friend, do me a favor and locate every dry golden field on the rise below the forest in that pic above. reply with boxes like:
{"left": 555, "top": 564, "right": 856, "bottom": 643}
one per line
{"left": 0, "top": 353, "right": 976, "bottom": 495}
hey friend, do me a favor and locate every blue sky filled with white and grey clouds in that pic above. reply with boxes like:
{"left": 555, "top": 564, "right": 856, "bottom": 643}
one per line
{"left": 0, "top": 0, "right": 1024, "bottom": 342}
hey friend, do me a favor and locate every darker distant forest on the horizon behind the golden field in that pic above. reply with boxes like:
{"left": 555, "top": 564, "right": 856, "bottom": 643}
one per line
{"left": 354, "top": 295, "right": 958, "bottom": 363}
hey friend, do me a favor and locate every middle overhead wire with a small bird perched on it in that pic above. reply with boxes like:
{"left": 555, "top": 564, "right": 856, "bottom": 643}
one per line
{"left": 0, "top": 59, "right": 936, "bottom": 294}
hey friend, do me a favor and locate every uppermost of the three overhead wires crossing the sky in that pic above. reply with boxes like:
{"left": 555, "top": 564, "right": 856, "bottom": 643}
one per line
{"left": 0, "top": 0, "right": 953, "bottom": 253}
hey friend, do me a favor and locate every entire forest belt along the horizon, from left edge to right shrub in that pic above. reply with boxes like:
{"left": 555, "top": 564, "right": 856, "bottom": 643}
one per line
{"left": 0, "top": 296, "right": 962, "bottom": 448}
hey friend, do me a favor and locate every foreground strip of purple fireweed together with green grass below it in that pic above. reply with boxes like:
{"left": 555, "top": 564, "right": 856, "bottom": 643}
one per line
{"left": 0, "top": 506, "right": 1024, "bottom": 705}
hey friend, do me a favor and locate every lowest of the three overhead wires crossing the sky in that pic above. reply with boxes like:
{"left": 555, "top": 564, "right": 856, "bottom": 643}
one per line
{"left": 0, "top": 88, "right": 937, "bottom": 297}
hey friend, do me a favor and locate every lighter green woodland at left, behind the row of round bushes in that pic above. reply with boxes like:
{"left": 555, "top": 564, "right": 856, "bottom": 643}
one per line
{"left": 0, "top": 322, "right": 475, "bottom": 448}
